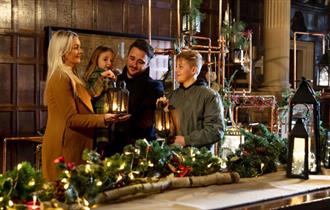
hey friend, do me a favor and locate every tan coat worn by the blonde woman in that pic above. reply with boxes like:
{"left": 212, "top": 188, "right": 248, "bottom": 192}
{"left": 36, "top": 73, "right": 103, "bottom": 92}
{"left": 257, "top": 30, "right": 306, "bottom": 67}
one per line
{"left": 42, "top": 71, "right": 106, "bottom": 181}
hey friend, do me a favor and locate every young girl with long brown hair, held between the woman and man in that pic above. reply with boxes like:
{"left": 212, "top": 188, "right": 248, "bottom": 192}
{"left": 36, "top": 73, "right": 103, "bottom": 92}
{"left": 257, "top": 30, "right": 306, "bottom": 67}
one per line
{"left": 84, "top": 46, "right": 116, "bottom": 156}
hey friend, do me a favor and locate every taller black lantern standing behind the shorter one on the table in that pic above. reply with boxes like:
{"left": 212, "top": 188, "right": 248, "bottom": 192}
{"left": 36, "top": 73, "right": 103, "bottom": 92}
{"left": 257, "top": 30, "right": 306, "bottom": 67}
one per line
{"left": 289, "top": 77, "right": 321, "bottom": 174}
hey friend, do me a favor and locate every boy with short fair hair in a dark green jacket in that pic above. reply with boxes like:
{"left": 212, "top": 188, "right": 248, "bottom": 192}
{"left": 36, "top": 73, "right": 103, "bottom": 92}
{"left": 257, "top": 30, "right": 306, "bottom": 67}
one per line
{"left": 160, "top": 50, "right": 224, "bottom": 147}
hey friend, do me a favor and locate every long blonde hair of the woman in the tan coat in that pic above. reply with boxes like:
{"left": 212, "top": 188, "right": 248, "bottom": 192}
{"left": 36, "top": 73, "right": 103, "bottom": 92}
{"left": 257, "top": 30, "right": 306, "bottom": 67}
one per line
{"left": 44, "top": 30, "right": 83, "bottom": 105}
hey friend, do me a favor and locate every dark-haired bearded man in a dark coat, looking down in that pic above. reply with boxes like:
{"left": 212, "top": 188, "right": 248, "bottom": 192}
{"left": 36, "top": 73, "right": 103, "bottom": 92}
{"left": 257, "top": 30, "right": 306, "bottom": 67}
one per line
{"left": 104, "top": 39, "right": 164, "bottom": 155}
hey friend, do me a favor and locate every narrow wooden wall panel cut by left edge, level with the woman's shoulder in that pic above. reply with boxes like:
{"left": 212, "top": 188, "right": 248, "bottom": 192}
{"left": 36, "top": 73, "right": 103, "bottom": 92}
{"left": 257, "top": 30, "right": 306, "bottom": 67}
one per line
{"left": 0, "top": 63, "right": 13, "bottom": 105}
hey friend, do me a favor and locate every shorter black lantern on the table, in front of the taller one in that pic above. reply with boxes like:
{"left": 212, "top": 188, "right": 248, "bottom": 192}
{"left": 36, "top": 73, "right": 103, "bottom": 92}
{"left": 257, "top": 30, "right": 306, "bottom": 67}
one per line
{"left": 286, "top": 118, "right": 309, "bottom": 179}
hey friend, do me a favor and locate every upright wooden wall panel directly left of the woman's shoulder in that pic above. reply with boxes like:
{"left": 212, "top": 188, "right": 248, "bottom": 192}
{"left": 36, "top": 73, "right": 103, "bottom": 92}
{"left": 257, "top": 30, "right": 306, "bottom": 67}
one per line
{"left": 17, "top": 64, "right": 37, "bottom": 105}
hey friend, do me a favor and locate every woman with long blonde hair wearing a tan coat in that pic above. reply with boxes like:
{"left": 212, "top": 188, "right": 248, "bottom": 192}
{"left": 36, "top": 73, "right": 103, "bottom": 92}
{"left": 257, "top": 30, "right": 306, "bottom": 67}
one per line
{"left": 42, "top": 30, "right": 129, "bottom": 181}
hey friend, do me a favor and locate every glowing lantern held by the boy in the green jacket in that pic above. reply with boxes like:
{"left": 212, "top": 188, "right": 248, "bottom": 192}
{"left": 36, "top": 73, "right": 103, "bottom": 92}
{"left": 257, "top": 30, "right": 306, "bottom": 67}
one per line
{"left": 155, "top": 107, "right": 173, "bottom": 141}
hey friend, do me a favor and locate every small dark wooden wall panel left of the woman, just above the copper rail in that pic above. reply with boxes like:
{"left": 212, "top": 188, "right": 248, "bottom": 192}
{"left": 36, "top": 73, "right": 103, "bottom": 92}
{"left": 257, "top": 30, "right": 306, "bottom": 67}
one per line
{"left": 17, "top": 111, "right": 37, "bottom": 135}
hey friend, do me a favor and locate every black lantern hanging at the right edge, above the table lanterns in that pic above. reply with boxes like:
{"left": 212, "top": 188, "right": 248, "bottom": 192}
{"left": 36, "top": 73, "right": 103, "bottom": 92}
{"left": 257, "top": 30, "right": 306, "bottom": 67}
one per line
{"left": 317, "top": 52, "right": 330, "bottom": 87}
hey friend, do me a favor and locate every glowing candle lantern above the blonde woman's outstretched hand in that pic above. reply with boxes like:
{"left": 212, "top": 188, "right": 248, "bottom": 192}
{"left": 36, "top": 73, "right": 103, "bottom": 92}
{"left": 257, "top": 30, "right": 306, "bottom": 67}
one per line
{"left": 108, "top": 81, "right": 129, "bottom": 115}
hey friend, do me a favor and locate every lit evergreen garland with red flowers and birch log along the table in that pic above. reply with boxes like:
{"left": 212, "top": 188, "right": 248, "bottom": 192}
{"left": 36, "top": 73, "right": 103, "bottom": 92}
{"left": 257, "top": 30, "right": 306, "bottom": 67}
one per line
{"left": 0, "top": 140, "right": 239, "bottom": 208}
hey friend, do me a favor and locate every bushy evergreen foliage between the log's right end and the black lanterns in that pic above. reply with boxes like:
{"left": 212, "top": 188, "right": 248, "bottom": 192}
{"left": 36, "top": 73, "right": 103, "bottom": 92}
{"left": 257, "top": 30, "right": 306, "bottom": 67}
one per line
{"left": 227, "top": 124, "right": 287, "bottom": 177}
